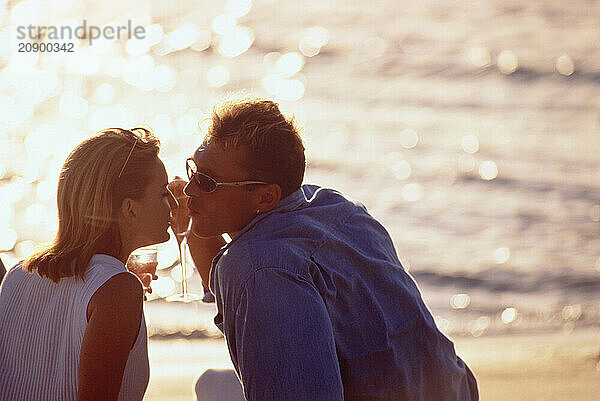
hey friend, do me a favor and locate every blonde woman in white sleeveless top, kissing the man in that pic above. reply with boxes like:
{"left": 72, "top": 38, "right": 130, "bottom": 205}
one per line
{"left": 0, "top": 128, "right": 176, "bottom": 401}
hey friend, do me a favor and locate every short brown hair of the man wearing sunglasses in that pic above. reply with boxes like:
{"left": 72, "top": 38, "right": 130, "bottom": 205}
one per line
{"left": 204, "top": 99, "right": 306, "bottom": 198}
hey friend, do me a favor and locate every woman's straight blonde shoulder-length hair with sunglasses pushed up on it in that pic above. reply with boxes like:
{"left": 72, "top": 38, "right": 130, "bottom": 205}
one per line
{"left": 23, "top": 128, "right": 160, "bottom": 282}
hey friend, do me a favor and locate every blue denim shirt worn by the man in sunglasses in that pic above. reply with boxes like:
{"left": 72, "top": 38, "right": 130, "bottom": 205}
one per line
{"left": 211, "top": 185, "right": 478, "bottom": 401}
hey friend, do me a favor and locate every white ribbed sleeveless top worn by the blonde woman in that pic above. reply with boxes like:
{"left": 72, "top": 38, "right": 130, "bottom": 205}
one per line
{"left": 0, "top": 255, "right": 150, "bottom": 401}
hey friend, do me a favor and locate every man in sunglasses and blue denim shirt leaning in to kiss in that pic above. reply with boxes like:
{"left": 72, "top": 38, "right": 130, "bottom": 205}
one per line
{"left": 178, "top": 99, "right": 478, "bottom": 401}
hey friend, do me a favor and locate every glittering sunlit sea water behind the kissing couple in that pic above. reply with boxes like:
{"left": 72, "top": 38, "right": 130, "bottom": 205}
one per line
{"left": 0, "top": 0, "right": 600, "bottom": 338}
